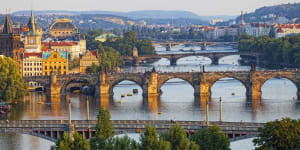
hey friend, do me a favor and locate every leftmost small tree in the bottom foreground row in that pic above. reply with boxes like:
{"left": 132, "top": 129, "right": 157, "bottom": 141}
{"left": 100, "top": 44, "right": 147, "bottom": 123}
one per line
{"left": 51, "top": 132, "right": 73, "bottom": 150}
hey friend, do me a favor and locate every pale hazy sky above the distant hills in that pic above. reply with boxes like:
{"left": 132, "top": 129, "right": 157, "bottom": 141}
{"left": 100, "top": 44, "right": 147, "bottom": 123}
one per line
{"left": 0, "top": 0, "right": 300, "bottom": 16}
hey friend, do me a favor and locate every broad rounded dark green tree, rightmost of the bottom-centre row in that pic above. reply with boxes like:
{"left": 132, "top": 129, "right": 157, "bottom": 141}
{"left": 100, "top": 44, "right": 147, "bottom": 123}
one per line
{"left": 191, "top": 126, "right": 230, "bottom": 150}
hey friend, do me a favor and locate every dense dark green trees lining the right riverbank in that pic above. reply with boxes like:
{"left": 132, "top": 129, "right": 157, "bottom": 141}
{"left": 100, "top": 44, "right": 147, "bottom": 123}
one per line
{"left": 239, "top": 34, "right": 300, "bottom": 67}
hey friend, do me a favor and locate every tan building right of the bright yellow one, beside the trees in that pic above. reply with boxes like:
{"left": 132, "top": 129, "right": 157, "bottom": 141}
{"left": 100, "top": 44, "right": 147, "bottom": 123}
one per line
{"left": 80, "top": 51, "right": 99, "bottom": 73}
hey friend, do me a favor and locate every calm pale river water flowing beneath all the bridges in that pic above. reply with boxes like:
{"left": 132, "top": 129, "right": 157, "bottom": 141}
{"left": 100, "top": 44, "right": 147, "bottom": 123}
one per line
{"left": 0, "top": 46, "right": 300, "bottom": 150}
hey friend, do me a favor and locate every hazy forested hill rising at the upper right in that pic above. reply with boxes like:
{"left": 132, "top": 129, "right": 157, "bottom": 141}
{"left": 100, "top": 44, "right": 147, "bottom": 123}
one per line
{"left": 236, "top": 3, "right": 300, "bottom": 22}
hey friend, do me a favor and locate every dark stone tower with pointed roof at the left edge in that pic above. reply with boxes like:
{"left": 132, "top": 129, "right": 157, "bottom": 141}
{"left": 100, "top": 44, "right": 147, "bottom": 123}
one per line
{"left": 0, "top": 15, "right": 21, "bottom": 62}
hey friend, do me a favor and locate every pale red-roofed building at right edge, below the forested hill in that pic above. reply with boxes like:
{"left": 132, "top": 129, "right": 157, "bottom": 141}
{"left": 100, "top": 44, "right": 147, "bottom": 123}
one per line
{"left": 275, "top": 24, "right": 300, "bottom": 38}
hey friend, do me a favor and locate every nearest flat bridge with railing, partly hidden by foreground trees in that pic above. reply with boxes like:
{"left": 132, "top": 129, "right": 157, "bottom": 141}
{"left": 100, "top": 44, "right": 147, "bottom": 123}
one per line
{"left": 0, "top": 120, "right": 264, "bottom": 142}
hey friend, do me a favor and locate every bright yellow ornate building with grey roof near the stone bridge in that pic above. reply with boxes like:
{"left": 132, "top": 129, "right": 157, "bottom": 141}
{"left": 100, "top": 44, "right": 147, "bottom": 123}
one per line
{"left": 43, "top": 51, "right": 68, "bottom": 76}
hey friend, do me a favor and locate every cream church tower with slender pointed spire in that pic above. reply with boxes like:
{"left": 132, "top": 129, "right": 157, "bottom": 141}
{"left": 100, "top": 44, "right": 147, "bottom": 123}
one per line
{"left": 24, "top": 10, "right": 42, "bottom": 53}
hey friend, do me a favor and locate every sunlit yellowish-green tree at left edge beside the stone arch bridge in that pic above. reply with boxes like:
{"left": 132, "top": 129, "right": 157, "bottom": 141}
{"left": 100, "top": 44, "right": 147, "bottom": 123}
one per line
{"left": 0, "top": 56, "right": 27, "bottom": 101}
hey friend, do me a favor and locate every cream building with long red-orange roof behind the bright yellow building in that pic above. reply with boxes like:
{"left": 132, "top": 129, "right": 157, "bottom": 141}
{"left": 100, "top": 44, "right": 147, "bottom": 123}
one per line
{"left": 42, "top": 41, "right": 83, "bottom": 60}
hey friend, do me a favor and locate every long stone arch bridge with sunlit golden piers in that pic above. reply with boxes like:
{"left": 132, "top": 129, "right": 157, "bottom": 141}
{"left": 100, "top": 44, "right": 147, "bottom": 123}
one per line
{"left": 24, "top": 69, "right": 300, "bottom": 101}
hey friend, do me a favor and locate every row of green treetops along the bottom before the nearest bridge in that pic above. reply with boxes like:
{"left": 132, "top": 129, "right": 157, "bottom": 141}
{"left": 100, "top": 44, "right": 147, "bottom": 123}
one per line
{"left": 52, "top": 107, "right": 230, "bottom": 150}
